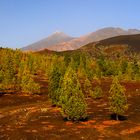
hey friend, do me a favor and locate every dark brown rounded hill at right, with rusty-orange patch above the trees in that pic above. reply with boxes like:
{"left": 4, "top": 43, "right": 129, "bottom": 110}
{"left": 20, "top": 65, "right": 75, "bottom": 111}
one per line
{"left": 77, "top": 34, "right": 140, "bottom": 56}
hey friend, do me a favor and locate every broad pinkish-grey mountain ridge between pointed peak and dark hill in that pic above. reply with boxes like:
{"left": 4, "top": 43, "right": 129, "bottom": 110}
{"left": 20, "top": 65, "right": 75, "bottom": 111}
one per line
{"left": 47, "top": 27, "right": 140, "bottom": 51}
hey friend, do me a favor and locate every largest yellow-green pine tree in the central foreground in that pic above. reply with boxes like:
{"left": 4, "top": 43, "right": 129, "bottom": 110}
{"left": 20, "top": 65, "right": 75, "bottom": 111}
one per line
{"left": 60, "top": 67, "right": 87, "bottom": 121}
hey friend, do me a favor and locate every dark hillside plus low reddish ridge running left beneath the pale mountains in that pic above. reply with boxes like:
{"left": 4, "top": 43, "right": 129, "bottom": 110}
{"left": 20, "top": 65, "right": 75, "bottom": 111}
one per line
{"left": 35, "top": 34, "right": 140, "bottom": 58}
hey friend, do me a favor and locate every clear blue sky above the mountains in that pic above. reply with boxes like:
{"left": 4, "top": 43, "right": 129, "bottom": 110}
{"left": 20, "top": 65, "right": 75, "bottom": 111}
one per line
{"left": 0, "top": 0, "right": 140, "bottom": 48}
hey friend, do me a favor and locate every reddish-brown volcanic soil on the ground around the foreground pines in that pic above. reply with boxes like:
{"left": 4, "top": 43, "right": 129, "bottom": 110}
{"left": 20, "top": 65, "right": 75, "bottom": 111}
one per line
{"left": 0, "top": 77, "right": 140, "bottom": 140}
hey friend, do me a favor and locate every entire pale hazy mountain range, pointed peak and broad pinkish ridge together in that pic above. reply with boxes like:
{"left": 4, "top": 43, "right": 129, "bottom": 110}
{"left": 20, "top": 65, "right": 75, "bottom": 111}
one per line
{"left": 22, "top": 27, "right": 140, "bottom": 51}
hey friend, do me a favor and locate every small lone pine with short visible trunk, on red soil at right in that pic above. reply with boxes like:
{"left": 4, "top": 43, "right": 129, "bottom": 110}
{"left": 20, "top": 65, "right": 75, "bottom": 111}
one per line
{"left": 109, "top": 77, "right": 128, "bottom": 120}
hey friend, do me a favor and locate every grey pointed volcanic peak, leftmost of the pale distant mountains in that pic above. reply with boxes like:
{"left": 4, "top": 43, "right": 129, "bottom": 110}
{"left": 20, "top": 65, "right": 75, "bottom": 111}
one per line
{"left": 21, "top": 32, "right": 74, "bottom": 51}
